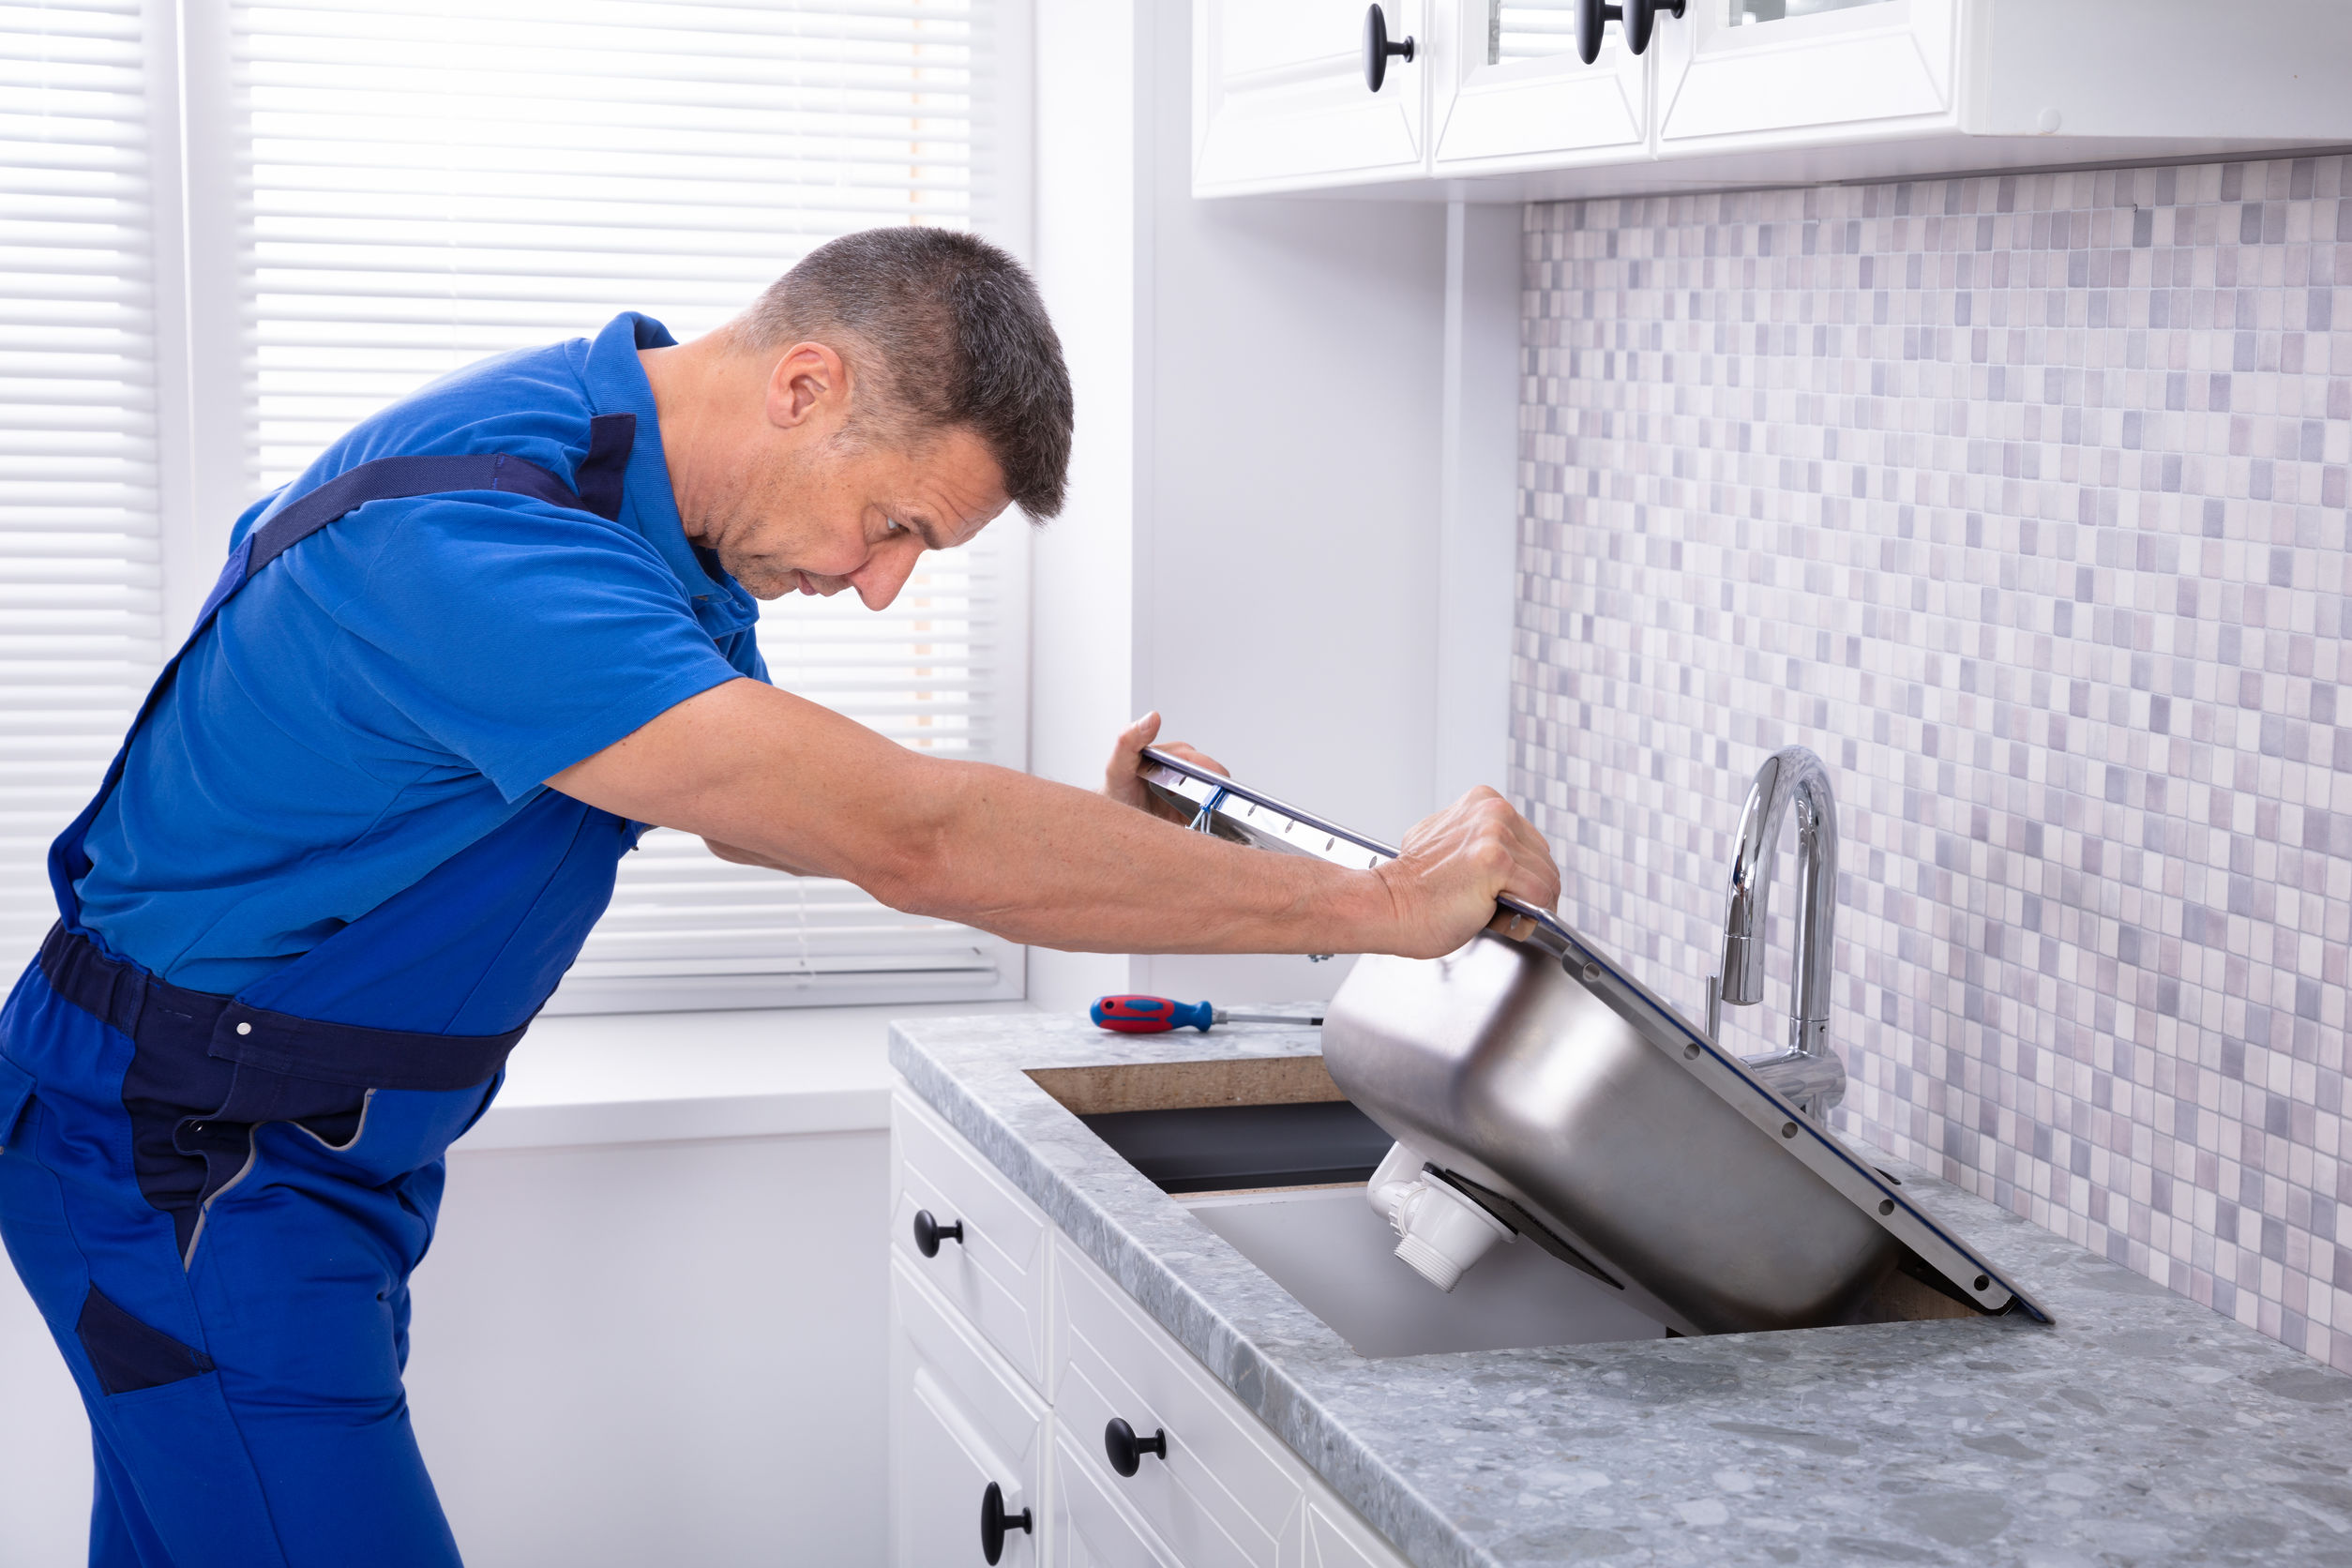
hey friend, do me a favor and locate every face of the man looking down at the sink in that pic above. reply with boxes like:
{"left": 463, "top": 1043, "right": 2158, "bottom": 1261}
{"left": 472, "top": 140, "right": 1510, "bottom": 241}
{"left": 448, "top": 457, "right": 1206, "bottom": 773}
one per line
{"left": 694, "top": 428, "right": 1006, "bottom": 609}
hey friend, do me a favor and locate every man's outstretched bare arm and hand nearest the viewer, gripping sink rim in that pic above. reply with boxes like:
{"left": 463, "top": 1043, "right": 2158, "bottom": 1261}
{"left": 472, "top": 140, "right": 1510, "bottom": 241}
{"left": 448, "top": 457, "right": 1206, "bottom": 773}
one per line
{"left": 548, "top": 679, "right": 1560, "bottom": 957}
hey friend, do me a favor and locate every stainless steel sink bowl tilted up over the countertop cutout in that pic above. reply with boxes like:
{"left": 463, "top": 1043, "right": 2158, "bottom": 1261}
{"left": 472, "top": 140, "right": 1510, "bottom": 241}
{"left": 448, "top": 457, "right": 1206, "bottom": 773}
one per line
{"left": 1324, "top": 936, "right": 1903, "bottom": 1333}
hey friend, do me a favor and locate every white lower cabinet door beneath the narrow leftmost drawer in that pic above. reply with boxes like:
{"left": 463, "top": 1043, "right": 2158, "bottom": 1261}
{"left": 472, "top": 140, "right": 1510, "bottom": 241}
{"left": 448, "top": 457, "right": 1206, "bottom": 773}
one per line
{"left": 889, "top": 1260, "right": 1045, "bottom": 1568}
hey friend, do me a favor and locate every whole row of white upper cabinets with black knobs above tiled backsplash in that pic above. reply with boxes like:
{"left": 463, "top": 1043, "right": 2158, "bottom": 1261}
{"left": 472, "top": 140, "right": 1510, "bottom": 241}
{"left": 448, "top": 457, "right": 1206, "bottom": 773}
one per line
{"left": 1193, "top": 0, "right": 2352, "bottom": 203}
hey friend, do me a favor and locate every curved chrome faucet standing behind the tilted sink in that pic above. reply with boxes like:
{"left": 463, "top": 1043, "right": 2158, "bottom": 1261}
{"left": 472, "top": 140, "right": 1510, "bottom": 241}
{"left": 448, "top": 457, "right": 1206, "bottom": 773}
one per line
{"left": 1708, "top": 746, "right": 1847, "bottom": 1122}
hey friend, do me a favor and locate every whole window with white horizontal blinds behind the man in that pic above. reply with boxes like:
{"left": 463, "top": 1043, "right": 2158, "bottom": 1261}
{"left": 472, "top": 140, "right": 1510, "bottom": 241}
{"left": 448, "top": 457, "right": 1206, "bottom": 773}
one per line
{"left": 0, "top": 0, "right": 1028, "bottom": 1011}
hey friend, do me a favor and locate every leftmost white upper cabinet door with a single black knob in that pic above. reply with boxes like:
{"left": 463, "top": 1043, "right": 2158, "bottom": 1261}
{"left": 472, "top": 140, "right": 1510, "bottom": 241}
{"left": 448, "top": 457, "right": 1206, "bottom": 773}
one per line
{"left": 1193, "top": 0, "right": 1430, "bottom": 195}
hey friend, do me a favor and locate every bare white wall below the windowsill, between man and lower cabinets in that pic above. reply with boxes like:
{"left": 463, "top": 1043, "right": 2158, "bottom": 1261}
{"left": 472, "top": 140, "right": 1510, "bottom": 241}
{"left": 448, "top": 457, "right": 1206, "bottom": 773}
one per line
{"left": 407, "top": 1131, "right": 889, "bottom": 1568}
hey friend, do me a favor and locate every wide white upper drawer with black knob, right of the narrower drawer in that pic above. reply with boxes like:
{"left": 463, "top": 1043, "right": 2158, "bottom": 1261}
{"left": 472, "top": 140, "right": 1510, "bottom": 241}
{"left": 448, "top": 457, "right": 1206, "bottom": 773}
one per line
{"left": 1054, "top": 1239, "right": 1305, "bottom": 1568}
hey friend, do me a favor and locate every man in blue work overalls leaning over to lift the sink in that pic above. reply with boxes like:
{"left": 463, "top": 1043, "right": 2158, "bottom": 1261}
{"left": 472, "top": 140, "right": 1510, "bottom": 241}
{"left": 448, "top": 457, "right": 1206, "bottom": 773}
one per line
{"left": 0, "top": 228, "right": 1557, "bottom": 1568}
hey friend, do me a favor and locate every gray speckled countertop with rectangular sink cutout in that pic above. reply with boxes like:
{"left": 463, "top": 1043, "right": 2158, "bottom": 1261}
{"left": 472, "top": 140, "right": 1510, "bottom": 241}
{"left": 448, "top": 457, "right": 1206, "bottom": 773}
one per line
{"left": 892, "top": 1016, "right": 2352, "bottom": 1568}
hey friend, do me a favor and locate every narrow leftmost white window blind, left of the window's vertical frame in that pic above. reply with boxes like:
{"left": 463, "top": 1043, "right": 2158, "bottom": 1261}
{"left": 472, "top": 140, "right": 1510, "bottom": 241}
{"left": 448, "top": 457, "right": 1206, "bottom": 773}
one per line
{"left": 0, "top": 0, "right": 162, "bottom": 973}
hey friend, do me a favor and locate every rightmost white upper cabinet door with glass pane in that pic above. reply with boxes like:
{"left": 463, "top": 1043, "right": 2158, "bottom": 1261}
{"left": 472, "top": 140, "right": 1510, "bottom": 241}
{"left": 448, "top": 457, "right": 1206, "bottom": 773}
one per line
{"left": 1656, "top": 0, "right": 1959, "bottom": 158}
